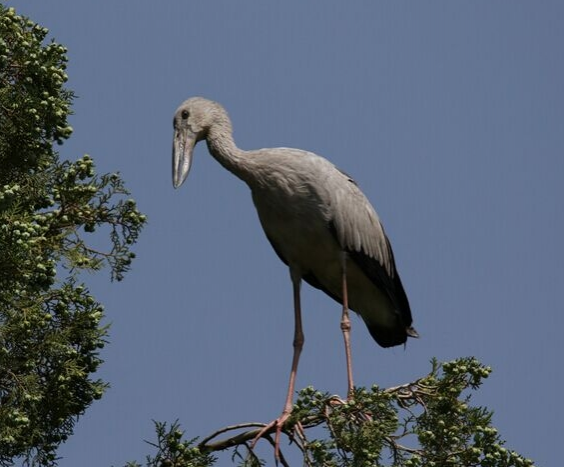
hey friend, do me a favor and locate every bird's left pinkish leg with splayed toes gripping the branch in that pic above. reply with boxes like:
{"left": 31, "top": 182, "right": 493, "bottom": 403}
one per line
{"left": 251, "top": 272, "right": 305, "bottom": 461}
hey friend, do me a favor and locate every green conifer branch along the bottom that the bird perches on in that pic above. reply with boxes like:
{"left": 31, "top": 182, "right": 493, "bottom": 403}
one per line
{"left": 128, "top": 358, "right": 534, "bottom": 467}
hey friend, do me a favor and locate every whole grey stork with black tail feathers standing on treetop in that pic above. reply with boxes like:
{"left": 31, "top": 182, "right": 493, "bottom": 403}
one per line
{"left": 173, "top": 97, "right": 417, "bottom": 454}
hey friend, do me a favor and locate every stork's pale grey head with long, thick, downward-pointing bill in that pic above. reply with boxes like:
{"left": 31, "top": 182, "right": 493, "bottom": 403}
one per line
{"left": 172, "top": 97, "right": 227, "bottom": 188}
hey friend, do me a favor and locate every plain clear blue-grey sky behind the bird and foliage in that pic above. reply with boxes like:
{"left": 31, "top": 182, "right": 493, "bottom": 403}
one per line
{"left": 8, "top": 0, "right": 564, "bottom": 467}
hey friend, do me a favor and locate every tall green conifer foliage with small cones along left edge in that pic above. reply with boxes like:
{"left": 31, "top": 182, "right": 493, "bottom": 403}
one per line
{"left": 0, "top": 4, "right": 146, "bottom": 465}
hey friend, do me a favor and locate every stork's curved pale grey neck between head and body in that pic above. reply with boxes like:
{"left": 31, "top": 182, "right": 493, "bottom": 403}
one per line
{"left": 206, "top": 125, "right": 252, "bottom": 181}
